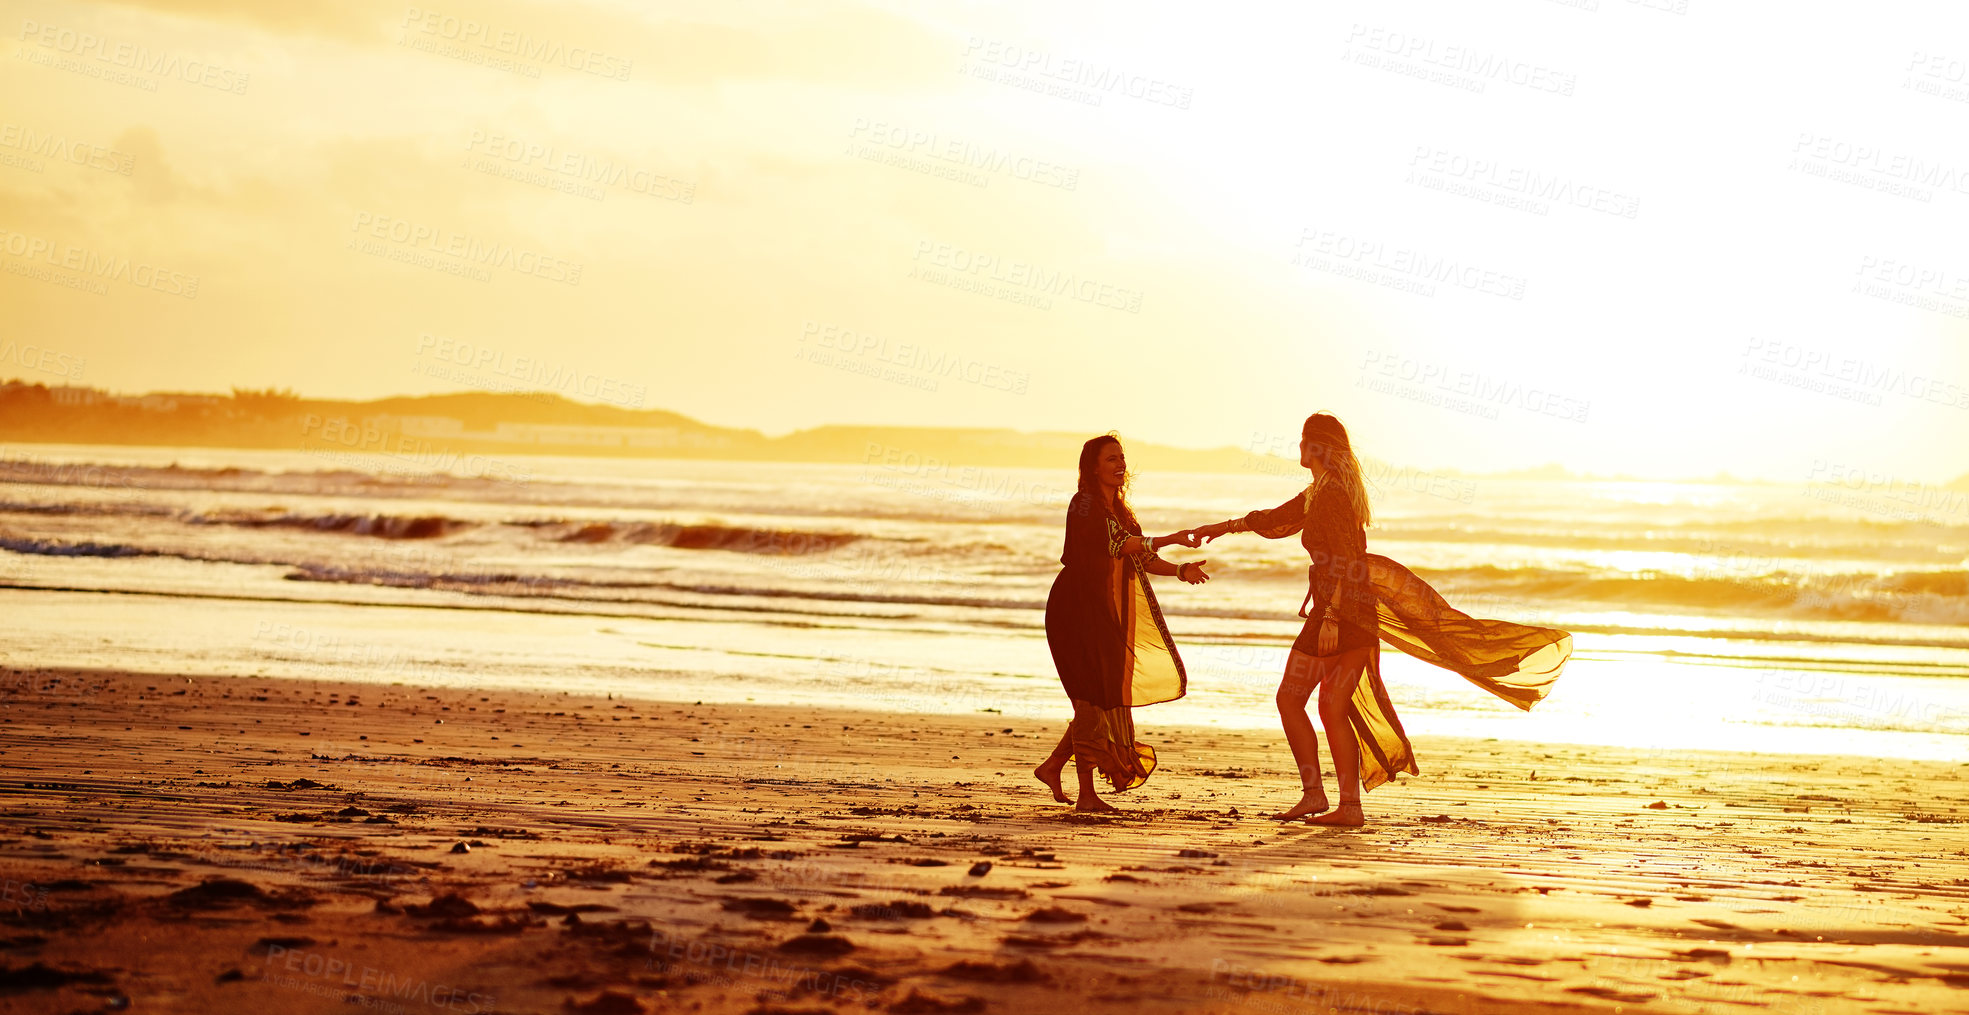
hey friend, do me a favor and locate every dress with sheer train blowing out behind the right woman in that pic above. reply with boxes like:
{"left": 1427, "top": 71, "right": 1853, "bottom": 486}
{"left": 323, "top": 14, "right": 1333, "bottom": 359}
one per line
{"left": 1244, "top": 481, "right": 1573, "bottom": 790}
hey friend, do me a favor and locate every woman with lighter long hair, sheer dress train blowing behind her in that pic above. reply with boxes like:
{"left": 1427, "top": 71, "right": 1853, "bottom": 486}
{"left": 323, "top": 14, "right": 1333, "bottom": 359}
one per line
{"left": 1189, "top": 412, "right": 1573, "bottom": 826}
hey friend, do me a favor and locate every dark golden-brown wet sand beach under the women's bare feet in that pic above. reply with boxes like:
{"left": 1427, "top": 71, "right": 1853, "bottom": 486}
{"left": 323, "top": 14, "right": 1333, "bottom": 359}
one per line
{"left": 0, "top": 670, "right": 1969, "bottom": 1013}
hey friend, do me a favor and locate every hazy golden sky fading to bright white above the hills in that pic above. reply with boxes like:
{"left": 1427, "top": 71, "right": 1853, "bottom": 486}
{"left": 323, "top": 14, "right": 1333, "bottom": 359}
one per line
{"left": 0, "top": 0, "right": 1969, "bottom": 479}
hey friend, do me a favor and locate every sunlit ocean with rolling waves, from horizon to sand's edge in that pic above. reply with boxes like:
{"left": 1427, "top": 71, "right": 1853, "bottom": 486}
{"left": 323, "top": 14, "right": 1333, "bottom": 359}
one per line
{"left": 0, "top": 445, "right": 1969, "bottom": 763}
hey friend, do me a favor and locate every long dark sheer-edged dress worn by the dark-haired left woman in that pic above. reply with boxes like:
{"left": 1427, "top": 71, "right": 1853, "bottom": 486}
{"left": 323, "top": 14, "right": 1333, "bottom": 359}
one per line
{"left": 1046, "top": 493, "right": 1189, "bottom": 790}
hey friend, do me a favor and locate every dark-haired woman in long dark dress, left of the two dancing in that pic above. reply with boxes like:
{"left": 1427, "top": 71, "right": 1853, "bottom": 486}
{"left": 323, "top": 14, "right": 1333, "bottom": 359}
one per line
{"left": 1032, "top": 434, "right": 1209, "bottom": 810}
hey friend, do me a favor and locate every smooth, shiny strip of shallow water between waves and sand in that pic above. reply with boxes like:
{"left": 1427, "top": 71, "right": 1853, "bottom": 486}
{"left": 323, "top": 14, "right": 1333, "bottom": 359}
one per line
{"left": 0, "top": 583, "right": 1969, "bottom": 761}
